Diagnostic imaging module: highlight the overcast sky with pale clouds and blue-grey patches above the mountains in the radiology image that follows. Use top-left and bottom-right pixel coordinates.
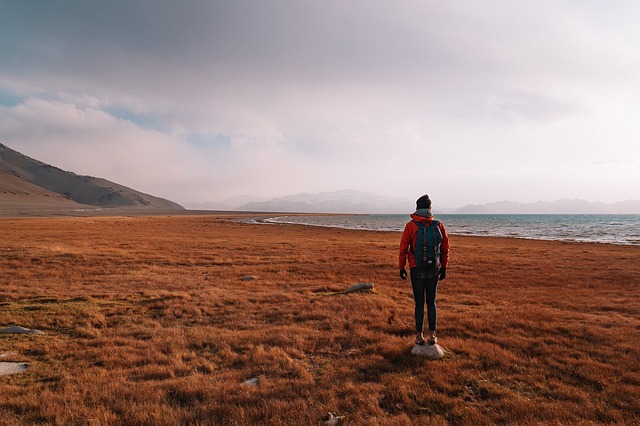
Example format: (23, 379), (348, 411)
(0, 0), (640, 207)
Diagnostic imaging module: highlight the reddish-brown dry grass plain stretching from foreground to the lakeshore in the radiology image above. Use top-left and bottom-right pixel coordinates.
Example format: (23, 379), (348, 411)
(0, 216), (640, 425)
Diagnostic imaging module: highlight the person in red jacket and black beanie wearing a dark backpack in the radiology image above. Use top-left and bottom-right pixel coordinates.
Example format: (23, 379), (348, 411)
(398, 194), (449, 345)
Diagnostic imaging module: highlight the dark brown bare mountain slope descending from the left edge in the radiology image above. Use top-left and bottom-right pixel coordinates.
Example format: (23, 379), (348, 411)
(0, 144), (183, 211)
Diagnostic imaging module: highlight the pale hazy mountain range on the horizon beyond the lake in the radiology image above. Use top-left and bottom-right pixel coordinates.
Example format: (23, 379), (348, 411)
(227, 190), (640, 214)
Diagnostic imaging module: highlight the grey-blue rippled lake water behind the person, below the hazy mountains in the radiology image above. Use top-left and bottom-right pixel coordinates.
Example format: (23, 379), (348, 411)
(254, 214), (640, 245)
